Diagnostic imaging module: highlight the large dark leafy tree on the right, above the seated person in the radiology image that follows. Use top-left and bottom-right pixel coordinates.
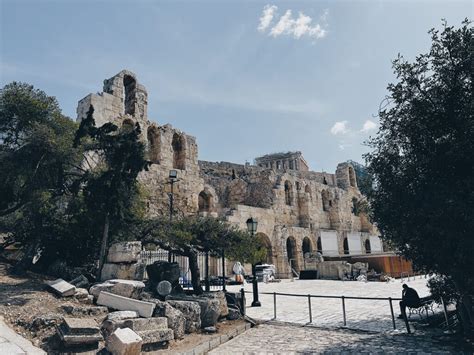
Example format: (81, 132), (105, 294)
(366, 19), (474, 336)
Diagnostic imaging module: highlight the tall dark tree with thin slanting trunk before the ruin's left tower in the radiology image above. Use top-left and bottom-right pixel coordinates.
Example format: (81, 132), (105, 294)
(74, 106), (149, 275)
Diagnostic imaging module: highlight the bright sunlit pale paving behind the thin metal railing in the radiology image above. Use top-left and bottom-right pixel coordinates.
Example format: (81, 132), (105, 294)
(228, 276), (436, 332)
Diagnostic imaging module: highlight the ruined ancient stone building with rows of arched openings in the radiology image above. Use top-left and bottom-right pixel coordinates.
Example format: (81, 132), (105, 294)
(77, 70), (382, 277)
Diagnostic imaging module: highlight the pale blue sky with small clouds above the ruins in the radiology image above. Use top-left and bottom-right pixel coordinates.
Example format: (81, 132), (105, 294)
(0, 0), (473, 172)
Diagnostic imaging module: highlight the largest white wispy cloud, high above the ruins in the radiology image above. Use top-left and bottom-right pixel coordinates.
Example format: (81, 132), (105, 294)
(257, 5), (329, 39)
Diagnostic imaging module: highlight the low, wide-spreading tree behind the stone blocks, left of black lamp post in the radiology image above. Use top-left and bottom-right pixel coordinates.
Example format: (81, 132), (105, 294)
(141, 216), (266, 294)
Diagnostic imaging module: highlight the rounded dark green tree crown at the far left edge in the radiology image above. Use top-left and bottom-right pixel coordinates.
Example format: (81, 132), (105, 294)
(0, 82), (79, 216)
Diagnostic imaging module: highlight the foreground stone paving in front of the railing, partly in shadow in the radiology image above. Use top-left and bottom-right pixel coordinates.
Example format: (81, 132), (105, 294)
(209, 322), (467, 355)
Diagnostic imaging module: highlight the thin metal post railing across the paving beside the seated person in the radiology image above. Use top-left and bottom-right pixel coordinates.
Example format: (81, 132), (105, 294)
(245, 291), (410, 333)
